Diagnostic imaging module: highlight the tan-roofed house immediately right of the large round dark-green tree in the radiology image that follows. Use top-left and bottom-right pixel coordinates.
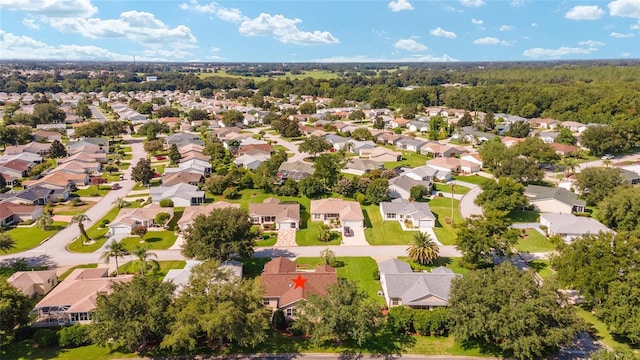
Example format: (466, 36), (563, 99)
(249, 197), (300, 230)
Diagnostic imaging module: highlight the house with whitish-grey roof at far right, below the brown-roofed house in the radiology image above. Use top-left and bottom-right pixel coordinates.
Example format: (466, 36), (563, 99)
(540, 213), (613, 243)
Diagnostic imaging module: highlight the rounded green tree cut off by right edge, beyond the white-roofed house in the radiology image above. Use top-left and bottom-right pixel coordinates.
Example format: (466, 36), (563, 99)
(597, 186), (640, 231)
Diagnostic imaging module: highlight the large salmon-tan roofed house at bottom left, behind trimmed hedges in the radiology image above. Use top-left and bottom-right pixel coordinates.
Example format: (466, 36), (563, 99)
(32, 268), (133, 326)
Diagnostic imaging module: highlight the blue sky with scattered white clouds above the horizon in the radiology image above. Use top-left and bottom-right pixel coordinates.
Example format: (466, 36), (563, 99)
(0, 0), (640, 62)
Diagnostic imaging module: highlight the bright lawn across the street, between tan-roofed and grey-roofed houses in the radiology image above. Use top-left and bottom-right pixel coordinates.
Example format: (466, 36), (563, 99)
(362, 205), (415, 245)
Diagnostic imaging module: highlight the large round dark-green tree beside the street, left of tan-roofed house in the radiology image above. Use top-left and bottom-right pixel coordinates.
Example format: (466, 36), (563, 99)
(182, 208), (255, 261)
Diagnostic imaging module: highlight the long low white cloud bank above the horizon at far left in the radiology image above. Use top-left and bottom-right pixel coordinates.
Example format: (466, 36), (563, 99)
(0, 30), (139, 61)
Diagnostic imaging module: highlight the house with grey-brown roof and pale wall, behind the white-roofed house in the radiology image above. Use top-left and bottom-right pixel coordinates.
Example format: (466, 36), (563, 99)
(524, 185), (587, 214)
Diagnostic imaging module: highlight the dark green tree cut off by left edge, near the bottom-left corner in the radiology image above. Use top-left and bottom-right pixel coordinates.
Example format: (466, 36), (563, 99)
(0, 282), (33, 338)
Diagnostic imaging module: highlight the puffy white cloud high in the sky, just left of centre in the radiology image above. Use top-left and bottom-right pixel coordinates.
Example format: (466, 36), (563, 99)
(238, 13), (340, 45)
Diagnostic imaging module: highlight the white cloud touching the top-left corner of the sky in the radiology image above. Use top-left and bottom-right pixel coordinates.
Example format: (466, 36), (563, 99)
(0, 0), (98, 17)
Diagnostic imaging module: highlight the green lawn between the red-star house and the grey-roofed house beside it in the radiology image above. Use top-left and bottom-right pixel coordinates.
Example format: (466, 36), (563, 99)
(296, 256), (385, 306)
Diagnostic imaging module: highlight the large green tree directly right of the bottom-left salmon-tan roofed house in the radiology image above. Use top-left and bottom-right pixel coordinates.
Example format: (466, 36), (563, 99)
(90, 276), (176, 352)
